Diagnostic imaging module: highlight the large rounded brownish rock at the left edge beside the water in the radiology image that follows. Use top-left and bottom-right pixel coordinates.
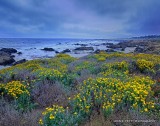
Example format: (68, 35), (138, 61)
(0, 51), (15, 65)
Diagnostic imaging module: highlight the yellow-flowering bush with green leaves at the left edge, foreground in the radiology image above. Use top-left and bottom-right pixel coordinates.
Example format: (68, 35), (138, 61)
(0, 81), (35, 111)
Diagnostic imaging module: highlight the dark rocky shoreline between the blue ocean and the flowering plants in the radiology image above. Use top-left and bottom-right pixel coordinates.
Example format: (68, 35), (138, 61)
(0, 39), (160, 69)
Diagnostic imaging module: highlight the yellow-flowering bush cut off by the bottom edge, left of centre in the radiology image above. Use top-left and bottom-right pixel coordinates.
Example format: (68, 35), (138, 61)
(39, 105), (85, 126)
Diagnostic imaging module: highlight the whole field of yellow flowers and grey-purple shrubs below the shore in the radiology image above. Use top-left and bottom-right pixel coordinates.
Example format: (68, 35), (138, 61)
(0, 52), (160, 126)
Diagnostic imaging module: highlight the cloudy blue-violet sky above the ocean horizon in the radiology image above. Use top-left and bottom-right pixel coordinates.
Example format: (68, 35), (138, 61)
(0, 0), (160, 39)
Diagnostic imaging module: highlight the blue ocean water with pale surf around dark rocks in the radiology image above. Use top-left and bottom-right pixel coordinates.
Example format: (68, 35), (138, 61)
(0, 38), (118, 68)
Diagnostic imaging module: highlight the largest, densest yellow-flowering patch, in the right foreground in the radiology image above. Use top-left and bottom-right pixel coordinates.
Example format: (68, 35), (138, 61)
(71, 76), (154, 116)
